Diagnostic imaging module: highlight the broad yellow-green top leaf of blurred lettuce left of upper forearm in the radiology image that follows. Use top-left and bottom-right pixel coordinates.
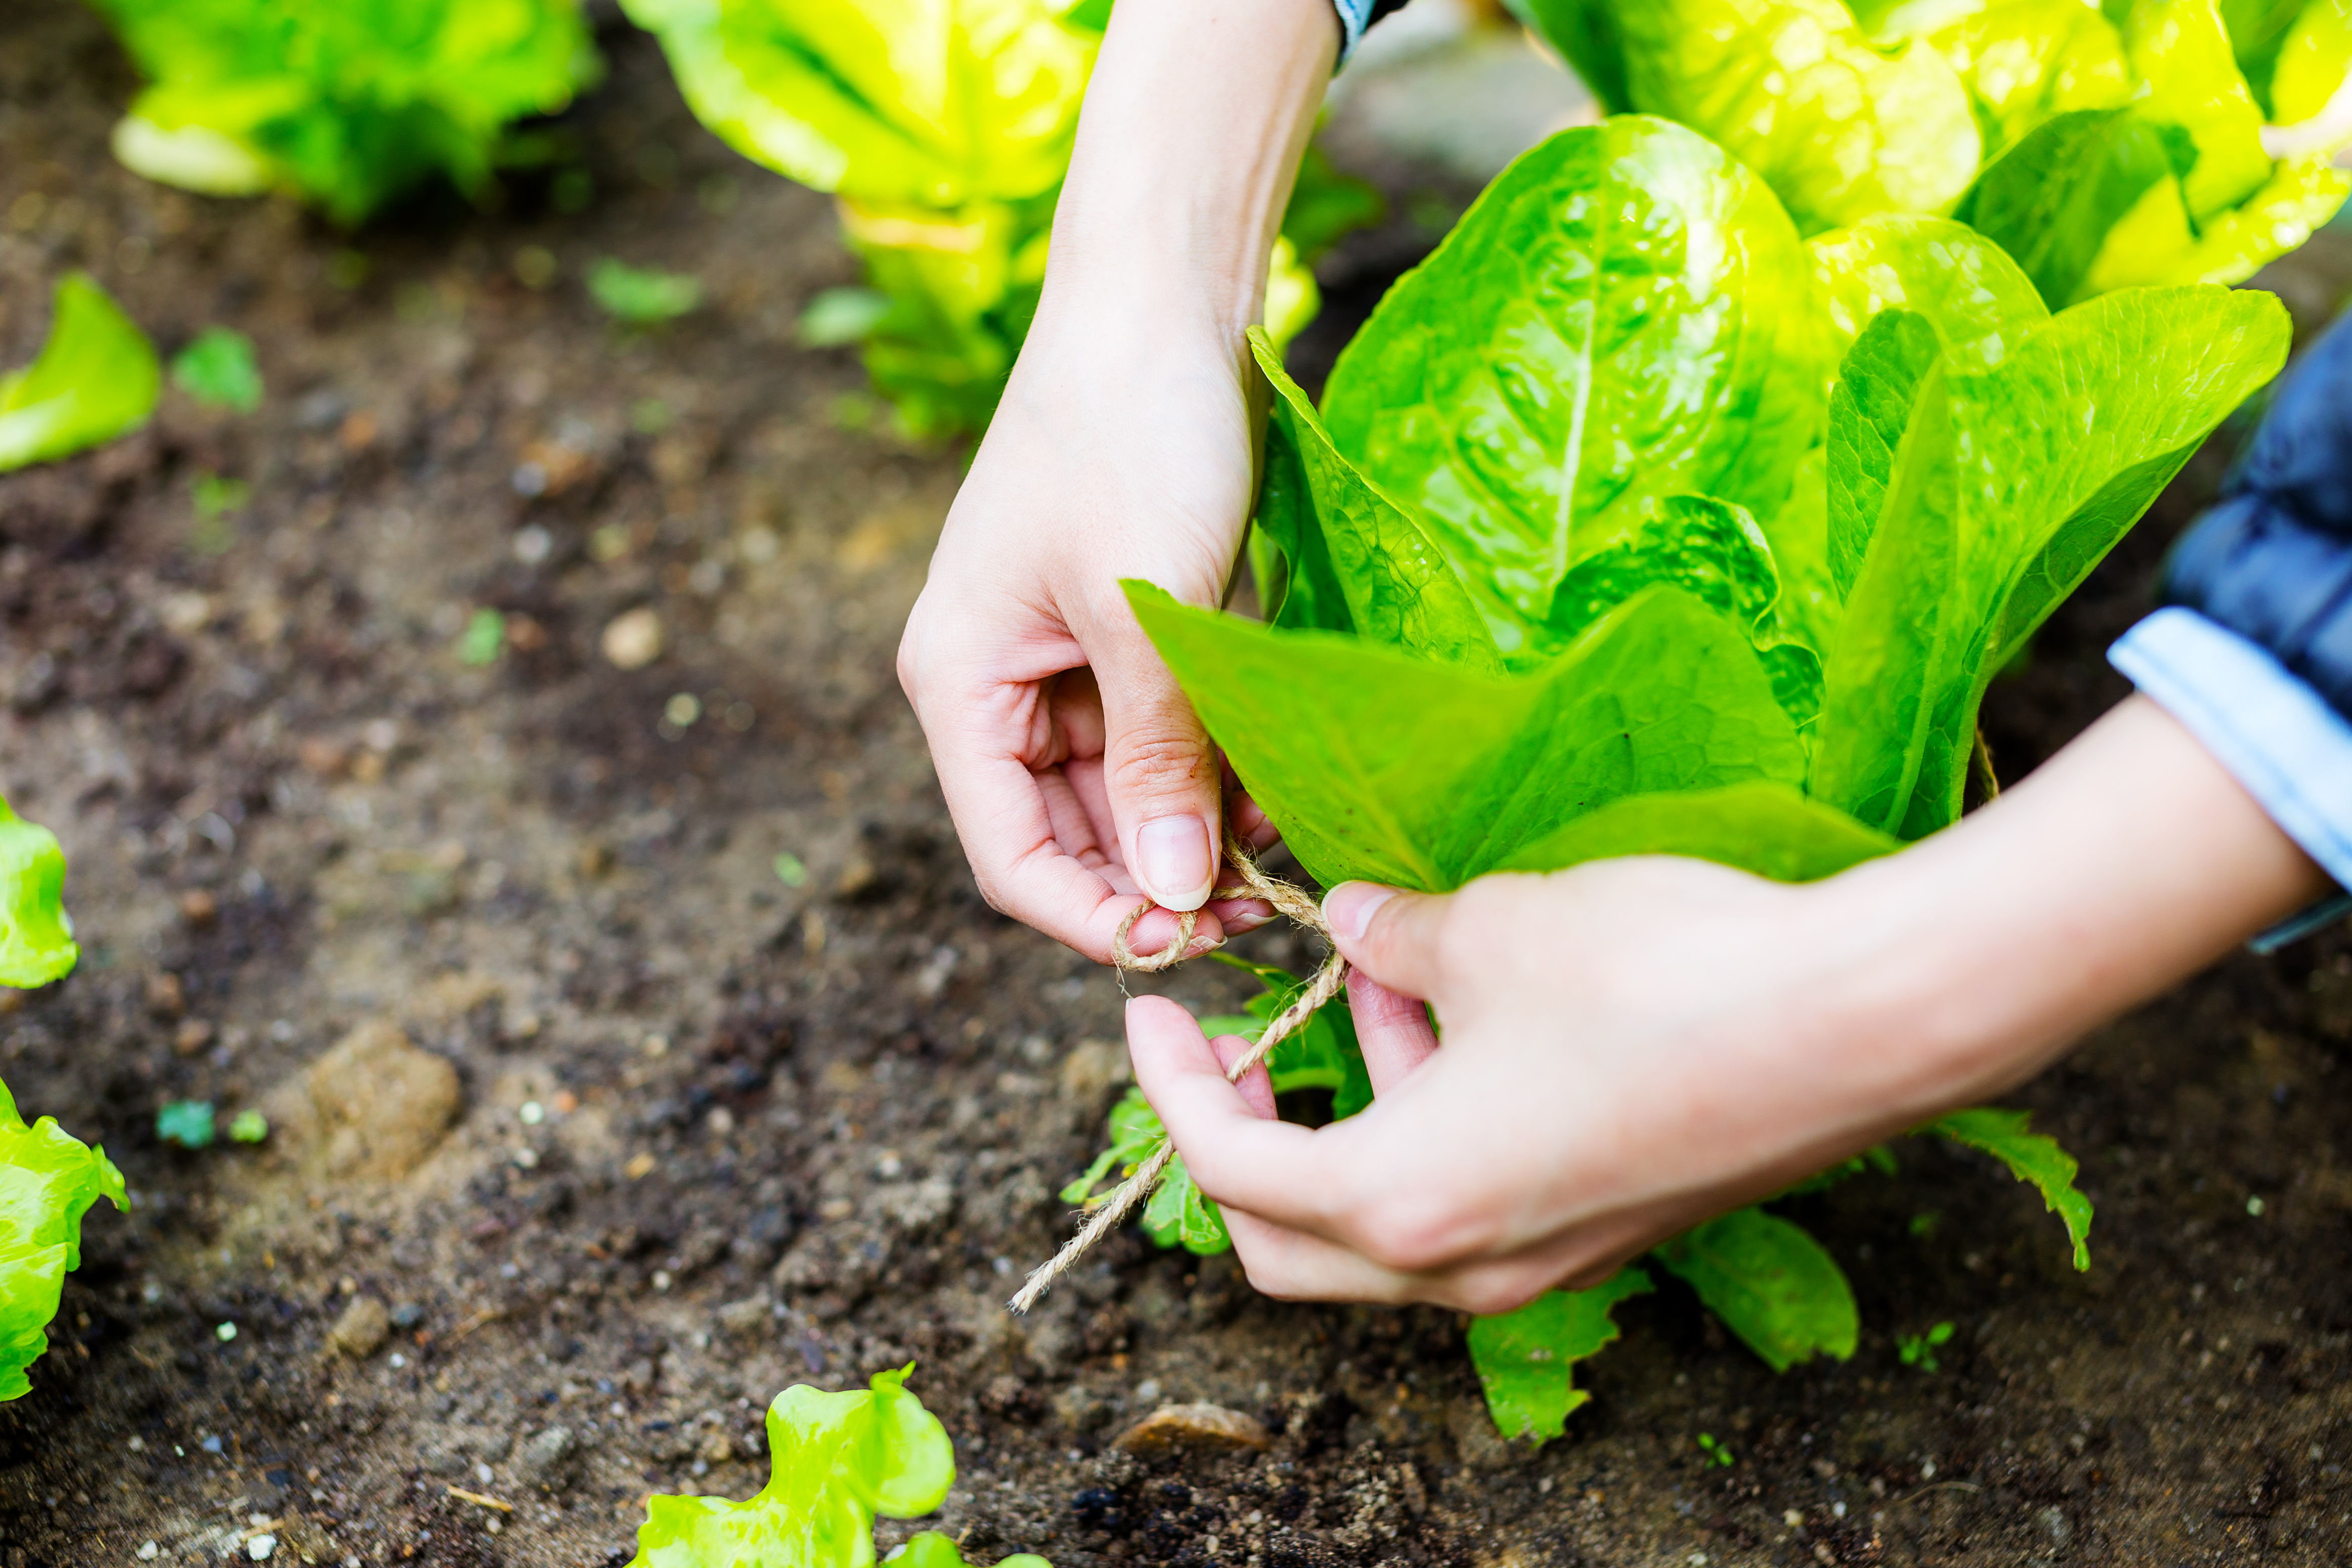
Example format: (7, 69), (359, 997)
(621, 0), (1101, 209)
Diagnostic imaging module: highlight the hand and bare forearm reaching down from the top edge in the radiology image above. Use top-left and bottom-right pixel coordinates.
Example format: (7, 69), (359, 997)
(898, 0), (1338, 962)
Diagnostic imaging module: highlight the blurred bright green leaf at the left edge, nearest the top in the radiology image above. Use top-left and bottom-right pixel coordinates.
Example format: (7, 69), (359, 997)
(0, 273), (162, 472)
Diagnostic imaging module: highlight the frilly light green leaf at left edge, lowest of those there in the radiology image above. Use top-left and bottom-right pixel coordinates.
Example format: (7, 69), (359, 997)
(0, 1084), (129, 1401)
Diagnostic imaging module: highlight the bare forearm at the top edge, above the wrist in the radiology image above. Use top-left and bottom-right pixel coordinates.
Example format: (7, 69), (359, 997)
(1039, 0), (1338, 351)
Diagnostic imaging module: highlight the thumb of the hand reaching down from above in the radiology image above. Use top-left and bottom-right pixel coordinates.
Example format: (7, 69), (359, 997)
(1086, 602), (1226, 910)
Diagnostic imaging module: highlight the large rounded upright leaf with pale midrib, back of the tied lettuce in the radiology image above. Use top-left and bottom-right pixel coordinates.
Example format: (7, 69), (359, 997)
(1326, 117), (1825, 668)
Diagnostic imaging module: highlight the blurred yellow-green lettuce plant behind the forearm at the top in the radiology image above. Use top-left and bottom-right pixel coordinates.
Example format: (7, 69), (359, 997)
(623, 0), (1378, 437)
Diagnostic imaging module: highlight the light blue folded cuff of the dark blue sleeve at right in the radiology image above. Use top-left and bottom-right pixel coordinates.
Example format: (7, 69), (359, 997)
(2107, 606), (2352, 952)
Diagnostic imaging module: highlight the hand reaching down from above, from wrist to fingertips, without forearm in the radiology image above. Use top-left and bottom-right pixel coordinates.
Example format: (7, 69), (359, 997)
(898, 301), (1273, 962)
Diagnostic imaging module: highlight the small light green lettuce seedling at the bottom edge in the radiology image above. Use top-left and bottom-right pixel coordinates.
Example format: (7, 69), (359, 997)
(630, 1364), (1047, 1568)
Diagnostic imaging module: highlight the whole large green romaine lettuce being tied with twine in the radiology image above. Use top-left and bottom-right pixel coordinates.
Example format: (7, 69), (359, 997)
(1070, 117), (2288, 1439)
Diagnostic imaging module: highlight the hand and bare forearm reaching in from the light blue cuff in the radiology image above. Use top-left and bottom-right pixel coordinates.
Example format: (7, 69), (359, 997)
(1129, 698), (2326, 1314)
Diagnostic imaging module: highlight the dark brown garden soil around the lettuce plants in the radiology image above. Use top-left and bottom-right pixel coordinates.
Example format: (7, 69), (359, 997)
(0, 0), (2352, 1568)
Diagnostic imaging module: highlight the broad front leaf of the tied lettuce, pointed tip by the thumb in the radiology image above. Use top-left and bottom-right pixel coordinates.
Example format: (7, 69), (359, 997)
(1126, 583), (1804, 891)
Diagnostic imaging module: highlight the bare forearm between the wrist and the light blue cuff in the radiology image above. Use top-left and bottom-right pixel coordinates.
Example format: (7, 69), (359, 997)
(1820, 698), (2329, 1110)
